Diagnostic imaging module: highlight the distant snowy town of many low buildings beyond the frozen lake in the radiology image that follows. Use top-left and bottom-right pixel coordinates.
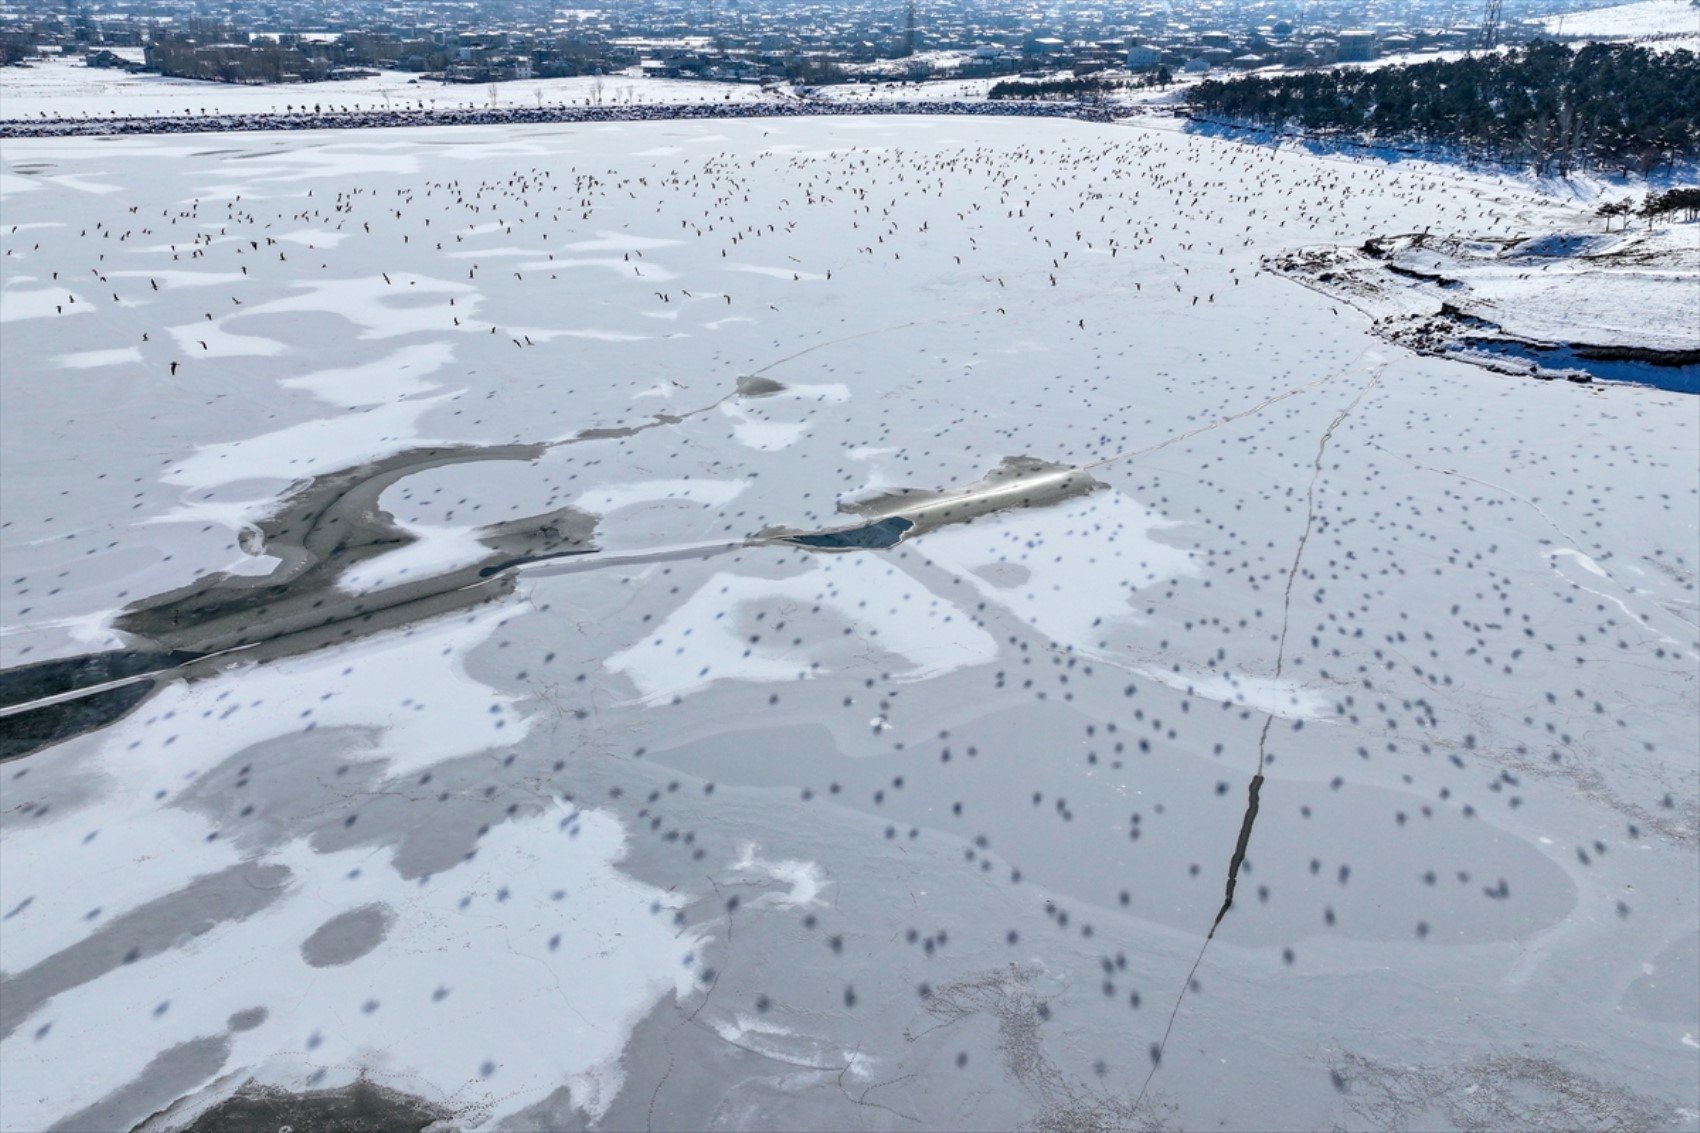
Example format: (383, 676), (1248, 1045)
(0, 0), (1652, 85)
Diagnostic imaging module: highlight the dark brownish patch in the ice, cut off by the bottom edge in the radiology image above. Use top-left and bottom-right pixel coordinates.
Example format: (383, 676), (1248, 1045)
(155, 1079), (454, 1133)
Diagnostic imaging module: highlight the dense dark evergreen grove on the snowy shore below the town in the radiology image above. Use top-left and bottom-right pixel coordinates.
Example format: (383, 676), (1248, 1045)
(1190, 41), (1700, 175)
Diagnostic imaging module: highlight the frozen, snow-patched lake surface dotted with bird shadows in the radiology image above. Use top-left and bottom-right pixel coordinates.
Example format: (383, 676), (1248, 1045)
(0, 108), (1700, 1130)
